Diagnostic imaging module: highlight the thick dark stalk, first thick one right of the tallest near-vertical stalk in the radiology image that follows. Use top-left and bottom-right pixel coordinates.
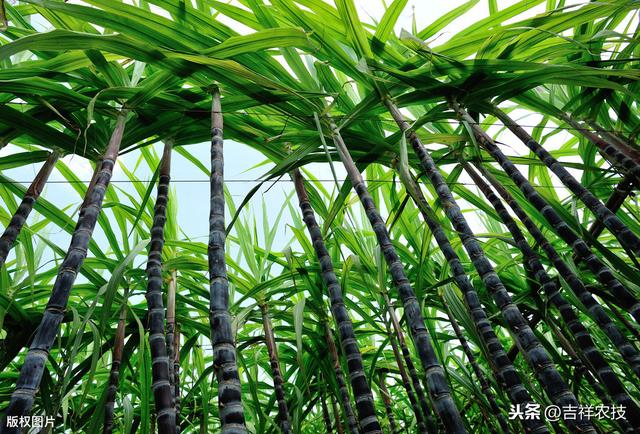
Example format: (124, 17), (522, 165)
(291, 169), (382, 434)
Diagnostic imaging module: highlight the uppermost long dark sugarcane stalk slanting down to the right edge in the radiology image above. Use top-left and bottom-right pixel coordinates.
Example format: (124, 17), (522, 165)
(493, 108), (640, 256)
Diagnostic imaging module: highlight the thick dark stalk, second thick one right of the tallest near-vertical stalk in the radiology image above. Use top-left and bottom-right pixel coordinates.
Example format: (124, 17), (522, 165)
(329, 116), (466, 434)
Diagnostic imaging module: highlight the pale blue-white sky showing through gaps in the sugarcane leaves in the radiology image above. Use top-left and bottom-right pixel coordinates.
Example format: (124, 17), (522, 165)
(0, 0), (604, 264)
